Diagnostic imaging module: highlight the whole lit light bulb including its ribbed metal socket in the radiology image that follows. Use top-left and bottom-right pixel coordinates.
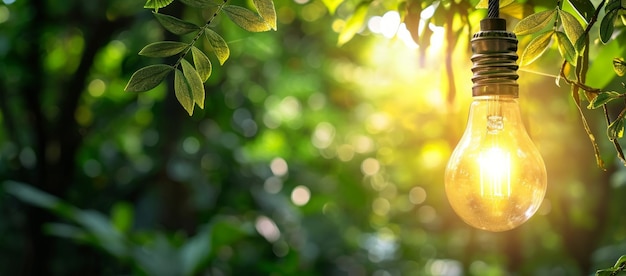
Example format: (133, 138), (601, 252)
(444, 19), (547, 232)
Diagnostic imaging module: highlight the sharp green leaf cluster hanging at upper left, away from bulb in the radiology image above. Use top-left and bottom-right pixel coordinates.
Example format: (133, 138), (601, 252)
(124, 0), (277, 116)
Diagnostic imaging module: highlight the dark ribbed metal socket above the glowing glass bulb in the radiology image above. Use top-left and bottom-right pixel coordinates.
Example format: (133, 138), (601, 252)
(472, 18), (519, 97)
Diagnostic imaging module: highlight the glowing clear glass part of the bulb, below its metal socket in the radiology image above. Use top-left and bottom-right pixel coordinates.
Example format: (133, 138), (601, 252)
(445, 95), (547, 232)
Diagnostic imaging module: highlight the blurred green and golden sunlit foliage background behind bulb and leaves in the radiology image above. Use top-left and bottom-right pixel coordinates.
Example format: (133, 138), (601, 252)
(0, 0), (626, 275)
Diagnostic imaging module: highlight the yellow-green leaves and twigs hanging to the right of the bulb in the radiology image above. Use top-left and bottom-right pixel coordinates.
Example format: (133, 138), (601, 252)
(513, 0), (626, 168)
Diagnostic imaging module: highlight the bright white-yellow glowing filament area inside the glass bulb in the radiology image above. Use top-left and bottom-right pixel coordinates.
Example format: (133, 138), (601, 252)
(478, 147), (512, 198)
